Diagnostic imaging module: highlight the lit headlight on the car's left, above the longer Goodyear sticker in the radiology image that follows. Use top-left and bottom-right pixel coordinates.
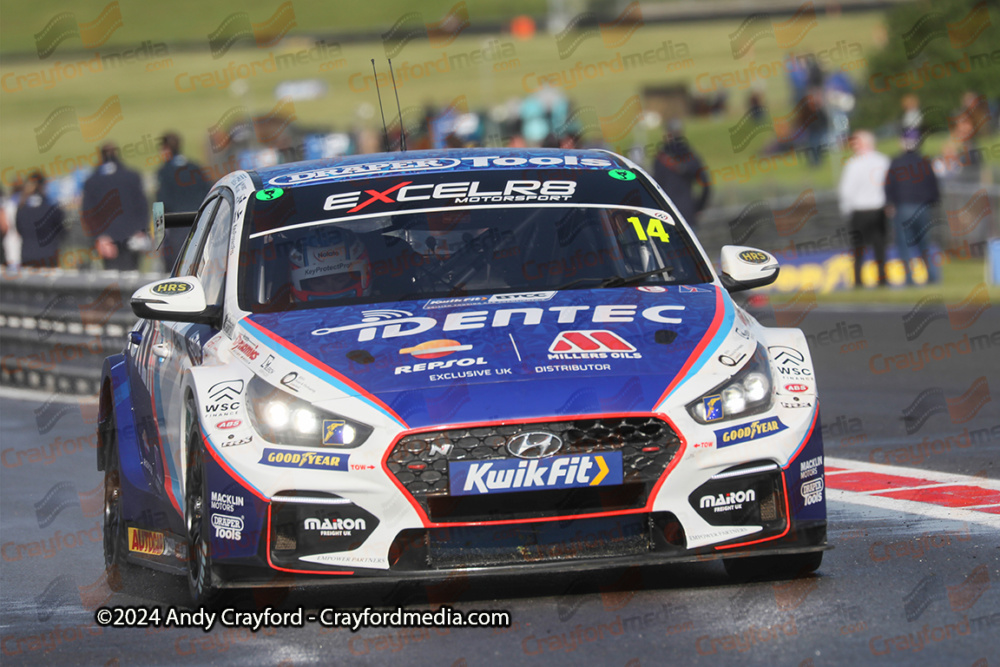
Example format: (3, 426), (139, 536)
(247, 377), (372, 448)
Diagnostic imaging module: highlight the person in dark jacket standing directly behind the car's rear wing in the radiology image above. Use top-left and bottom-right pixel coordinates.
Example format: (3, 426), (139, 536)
(156, 132), (211, 271)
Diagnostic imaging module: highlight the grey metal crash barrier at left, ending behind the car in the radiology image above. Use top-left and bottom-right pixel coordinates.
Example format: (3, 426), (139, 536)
(0, 269), (162, 395)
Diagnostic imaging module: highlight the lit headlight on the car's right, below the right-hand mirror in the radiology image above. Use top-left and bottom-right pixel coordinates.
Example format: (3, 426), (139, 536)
(688, 345), (772, 424)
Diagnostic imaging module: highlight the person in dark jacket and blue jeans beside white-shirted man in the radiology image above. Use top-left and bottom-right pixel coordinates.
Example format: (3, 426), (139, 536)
(885, 128), (941, 285)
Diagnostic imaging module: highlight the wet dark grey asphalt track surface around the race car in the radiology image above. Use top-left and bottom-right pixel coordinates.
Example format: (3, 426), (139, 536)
(0, 308), (1000, 667)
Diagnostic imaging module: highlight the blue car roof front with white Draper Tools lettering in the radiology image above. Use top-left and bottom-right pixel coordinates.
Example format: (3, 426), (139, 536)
(251, 148), (630, 188)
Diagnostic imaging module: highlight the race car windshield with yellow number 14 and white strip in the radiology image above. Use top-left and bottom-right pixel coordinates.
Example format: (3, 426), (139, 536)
(239, 172), (712, 312)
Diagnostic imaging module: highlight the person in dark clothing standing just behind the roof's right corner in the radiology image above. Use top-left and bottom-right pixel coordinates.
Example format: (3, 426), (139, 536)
(653, 121), (712, 227)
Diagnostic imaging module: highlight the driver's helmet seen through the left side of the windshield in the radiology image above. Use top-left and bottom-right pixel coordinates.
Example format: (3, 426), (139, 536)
(289, 229), (372, 302)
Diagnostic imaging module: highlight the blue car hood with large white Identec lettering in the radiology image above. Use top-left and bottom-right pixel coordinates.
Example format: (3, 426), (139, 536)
(236, 285), (733, 428)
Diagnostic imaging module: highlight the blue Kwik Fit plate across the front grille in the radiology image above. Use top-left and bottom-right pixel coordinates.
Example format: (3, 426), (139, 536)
(448, 452), (622, 496)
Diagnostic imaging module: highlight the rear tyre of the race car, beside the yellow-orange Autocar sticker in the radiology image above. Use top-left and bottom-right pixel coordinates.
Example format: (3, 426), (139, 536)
(104, 410), (137, 592)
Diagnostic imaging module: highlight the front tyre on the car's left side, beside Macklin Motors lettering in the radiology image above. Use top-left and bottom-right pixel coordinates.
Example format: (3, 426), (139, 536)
(184, 398), (221, 607)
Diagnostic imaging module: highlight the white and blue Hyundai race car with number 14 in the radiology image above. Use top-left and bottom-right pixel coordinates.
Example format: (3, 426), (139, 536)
(98, 149), (827, 603)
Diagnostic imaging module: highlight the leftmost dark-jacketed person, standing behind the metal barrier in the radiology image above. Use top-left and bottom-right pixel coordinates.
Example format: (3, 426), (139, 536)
(14, 171), (66, 268)
